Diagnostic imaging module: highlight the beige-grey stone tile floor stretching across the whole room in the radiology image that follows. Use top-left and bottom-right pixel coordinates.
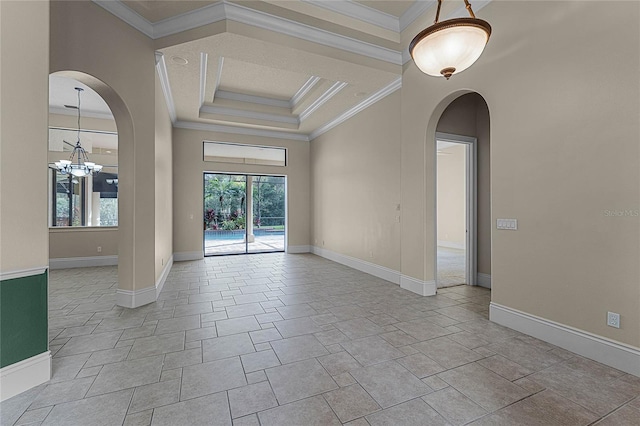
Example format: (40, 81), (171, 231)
(0, 253), (640, 426)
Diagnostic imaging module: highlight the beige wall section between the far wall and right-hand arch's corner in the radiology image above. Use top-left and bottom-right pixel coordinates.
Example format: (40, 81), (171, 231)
(311, 91), (405, 270)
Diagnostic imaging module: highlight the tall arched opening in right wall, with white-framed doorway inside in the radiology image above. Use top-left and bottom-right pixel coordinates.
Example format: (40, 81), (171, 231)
(426, 90), (491, 300)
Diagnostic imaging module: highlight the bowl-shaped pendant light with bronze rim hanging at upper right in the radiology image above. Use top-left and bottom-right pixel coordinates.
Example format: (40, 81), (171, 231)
(409, 0), (491, 80)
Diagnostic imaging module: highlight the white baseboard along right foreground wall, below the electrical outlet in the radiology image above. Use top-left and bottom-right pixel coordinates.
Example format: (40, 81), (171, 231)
(489, 302), (640, 377)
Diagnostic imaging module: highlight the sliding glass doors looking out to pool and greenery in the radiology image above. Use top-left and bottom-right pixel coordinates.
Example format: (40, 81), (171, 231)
(203, 173), (286, 256)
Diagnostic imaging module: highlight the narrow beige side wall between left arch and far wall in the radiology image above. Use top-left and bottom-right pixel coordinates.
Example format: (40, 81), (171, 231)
(155, 73), (173, 282)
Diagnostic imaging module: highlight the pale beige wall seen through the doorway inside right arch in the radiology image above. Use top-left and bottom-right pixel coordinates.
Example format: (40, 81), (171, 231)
(437, 144), (467, 249)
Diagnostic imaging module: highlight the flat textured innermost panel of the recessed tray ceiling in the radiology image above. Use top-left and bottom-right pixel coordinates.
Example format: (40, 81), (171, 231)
(218, 58), (311, 101)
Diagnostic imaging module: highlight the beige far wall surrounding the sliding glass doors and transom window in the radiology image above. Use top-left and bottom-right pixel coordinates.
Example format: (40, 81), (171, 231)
(173, 128), (310, 253)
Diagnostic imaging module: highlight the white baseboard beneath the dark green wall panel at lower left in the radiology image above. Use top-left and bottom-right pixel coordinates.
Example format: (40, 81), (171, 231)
(0, 351), (51, 401)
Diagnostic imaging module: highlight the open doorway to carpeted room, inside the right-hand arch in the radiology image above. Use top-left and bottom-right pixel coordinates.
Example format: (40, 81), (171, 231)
(436, 133), (476, 288)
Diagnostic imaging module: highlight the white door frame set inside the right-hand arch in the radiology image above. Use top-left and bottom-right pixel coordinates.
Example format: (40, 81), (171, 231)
(433, 132), (478, 289)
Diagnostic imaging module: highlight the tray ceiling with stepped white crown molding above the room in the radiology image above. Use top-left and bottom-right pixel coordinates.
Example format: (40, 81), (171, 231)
(94, 0), (488, 140)
